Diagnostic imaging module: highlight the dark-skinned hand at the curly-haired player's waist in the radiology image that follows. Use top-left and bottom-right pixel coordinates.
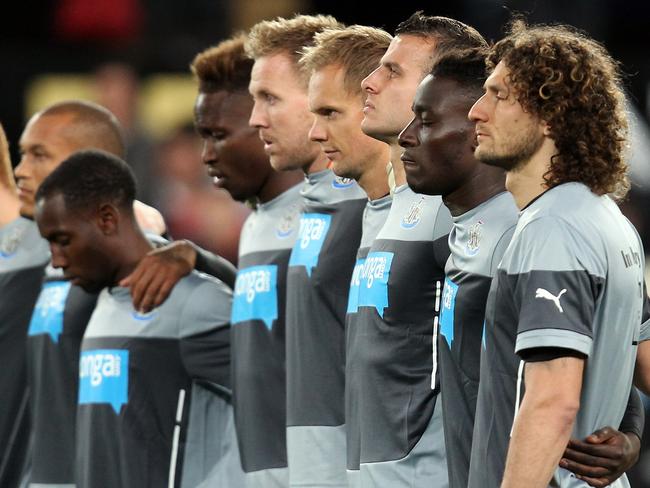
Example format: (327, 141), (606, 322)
(560, 427), (641, 488)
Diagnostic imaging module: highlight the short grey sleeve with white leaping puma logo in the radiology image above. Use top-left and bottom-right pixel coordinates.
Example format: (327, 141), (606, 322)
(508, 217), (604, 356)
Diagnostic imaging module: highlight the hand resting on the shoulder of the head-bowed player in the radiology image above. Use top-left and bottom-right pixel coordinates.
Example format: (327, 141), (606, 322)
(120, 241), (196, 313)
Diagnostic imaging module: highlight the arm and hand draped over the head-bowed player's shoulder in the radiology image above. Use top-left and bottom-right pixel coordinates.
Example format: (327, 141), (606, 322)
(120, 240), (237, 312)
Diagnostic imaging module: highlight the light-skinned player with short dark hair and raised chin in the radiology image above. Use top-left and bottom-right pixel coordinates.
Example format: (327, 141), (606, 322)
(348, 13), (485, 487)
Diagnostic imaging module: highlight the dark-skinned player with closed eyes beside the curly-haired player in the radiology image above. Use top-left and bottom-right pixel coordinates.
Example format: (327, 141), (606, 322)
(400, 45), (643, 488)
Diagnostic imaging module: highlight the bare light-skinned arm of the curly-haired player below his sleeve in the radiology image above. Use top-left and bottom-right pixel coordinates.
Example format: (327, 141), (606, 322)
(502, 351), (584, 488)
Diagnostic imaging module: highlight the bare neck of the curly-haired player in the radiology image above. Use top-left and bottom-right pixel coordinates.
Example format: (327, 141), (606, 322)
(506, 138), (557, 209)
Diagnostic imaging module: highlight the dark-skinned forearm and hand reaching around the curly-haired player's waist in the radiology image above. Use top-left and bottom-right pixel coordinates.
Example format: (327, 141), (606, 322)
(560, 387), (645, 488)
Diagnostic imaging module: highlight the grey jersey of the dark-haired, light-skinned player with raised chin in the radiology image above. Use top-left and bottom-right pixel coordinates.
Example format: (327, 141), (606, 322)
(348, 186), (452, 486)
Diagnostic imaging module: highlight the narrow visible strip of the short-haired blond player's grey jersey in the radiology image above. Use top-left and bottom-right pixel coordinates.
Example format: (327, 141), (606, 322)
(345, 195), (393, 480)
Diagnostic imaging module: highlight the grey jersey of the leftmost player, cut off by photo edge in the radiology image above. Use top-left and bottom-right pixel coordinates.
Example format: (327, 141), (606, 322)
(0, 217), (50, 487)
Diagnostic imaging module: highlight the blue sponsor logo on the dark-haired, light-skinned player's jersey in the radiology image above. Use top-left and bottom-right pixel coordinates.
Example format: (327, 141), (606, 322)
(358, 252), (393, 318)
